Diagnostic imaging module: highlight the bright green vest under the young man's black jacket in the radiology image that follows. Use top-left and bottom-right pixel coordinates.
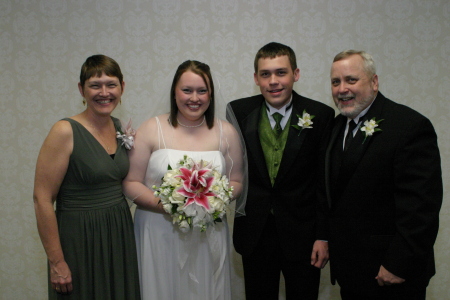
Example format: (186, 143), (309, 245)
(259, 104), (292, 186)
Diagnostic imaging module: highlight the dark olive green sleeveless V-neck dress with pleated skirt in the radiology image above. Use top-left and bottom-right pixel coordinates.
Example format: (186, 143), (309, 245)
(49, 118), (140, 300)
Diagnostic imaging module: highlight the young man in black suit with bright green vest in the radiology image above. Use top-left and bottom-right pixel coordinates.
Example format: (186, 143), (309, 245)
(230, 43), (334, 300)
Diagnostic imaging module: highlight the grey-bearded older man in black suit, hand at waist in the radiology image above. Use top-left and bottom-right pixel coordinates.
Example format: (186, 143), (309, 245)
(323, 50), (442, 300)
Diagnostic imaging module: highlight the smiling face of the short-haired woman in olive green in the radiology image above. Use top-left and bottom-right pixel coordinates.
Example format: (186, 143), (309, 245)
(78, 73), (125, 115)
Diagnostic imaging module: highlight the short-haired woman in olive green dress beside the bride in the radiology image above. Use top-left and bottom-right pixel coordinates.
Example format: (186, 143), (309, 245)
(33, 55), (140, 299)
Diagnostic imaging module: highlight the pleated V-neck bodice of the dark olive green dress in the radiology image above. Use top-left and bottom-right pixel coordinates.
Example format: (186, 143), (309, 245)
(57, 118), (129, 210)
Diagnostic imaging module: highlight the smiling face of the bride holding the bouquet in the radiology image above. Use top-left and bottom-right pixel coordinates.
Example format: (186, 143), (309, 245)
(175, 71), (210, 122)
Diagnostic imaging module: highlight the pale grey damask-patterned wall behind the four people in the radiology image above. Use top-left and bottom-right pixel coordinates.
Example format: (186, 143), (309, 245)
(0, 0), (450, 299)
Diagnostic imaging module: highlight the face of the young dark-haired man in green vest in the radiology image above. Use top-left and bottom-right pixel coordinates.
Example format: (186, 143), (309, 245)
(254, 55), (300, 109)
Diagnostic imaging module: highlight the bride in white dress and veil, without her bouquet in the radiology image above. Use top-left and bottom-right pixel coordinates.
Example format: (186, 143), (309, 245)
(124, 61), (245, 300)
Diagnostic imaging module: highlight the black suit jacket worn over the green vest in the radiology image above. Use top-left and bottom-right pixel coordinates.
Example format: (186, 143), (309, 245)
(230, 92), (334, 261)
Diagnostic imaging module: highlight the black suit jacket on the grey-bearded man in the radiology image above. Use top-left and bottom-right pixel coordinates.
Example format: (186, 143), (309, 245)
(322, 93), (442, 291)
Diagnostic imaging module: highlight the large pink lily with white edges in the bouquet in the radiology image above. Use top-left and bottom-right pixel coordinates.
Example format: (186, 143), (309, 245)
(176, 162), (216, 210)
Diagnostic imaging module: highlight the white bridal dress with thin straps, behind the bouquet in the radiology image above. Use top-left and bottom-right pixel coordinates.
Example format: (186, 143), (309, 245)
(134, 119), (231, 300)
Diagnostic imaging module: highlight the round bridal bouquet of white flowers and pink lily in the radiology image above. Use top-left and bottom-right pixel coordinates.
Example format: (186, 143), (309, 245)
(152, 155), (233, 232)
